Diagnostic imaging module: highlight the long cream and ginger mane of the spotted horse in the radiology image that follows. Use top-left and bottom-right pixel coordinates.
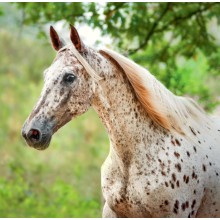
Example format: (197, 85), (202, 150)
(101, 49), (211, 135)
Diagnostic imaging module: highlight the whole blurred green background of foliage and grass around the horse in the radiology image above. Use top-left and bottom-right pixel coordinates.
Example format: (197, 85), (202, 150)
(0, 3), (220, 217)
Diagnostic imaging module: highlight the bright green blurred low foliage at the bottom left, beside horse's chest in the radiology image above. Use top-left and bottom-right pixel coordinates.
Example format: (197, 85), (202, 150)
(0, 166), (101, 218)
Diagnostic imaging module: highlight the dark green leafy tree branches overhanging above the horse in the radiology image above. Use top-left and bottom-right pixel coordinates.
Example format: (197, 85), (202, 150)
(12, 2), (220, 69)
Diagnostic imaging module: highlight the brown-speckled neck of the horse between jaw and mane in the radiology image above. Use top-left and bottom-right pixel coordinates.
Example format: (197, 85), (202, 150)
(84, 48), (162, 162)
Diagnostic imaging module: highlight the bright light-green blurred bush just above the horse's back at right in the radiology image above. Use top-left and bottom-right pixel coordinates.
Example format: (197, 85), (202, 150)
(169, 53), (218, 110)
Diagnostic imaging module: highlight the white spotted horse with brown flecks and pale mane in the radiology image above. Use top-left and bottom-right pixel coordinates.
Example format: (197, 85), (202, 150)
(22, 26), (220, 217)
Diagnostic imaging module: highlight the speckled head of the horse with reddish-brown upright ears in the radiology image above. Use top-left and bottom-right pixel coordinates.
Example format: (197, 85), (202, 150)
(22, 26), (95, 150)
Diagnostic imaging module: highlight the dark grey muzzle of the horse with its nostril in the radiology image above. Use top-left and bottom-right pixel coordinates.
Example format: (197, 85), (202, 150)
(21, 121), (52, 150)
